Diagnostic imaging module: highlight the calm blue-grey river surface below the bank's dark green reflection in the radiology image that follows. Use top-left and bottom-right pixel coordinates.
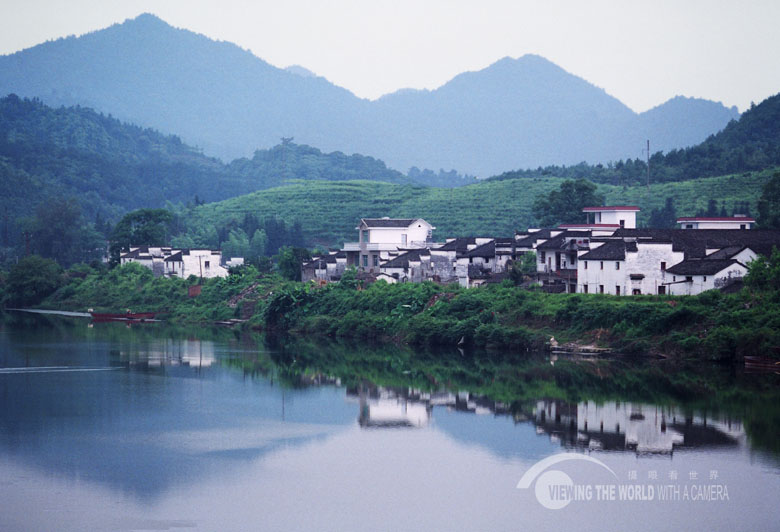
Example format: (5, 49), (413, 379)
(0, 317), (780, 531)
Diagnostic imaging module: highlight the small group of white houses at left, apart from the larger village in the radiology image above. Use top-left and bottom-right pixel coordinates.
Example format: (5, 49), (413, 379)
(119, 246), (244, 278)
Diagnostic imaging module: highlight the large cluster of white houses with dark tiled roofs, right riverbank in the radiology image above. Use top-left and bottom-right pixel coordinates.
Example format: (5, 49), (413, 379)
(302, 206), (780, 295)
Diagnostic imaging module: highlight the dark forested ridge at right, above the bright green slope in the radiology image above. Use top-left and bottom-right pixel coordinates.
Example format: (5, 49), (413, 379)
(490, 94), (780, 185)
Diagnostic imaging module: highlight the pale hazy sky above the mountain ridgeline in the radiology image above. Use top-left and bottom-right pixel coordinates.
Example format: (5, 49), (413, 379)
(0, 0), (780, 111)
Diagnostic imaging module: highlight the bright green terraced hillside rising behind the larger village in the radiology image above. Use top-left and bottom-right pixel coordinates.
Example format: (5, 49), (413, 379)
(183, 170), (775, 246)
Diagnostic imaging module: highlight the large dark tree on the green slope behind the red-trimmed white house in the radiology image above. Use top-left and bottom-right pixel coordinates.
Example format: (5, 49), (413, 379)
(533, 179), (604, 227)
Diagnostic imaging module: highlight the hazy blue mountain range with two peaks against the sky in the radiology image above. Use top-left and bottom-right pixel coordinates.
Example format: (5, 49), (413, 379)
(0, 14), (738, 176)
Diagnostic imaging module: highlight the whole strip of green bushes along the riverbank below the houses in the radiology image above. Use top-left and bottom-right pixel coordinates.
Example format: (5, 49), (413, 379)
(0, 250), (780, 361)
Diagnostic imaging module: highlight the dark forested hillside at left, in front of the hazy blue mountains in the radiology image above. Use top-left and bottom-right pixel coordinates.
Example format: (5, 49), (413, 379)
(0, 95), (426, 247)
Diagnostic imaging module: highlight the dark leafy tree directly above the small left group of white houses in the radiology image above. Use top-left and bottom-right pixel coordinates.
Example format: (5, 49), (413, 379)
(109, 209), (173, 265)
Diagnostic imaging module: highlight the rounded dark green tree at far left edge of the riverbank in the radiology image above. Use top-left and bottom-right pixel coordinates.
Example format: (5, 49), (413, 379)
(6, 255), (62, 306)
